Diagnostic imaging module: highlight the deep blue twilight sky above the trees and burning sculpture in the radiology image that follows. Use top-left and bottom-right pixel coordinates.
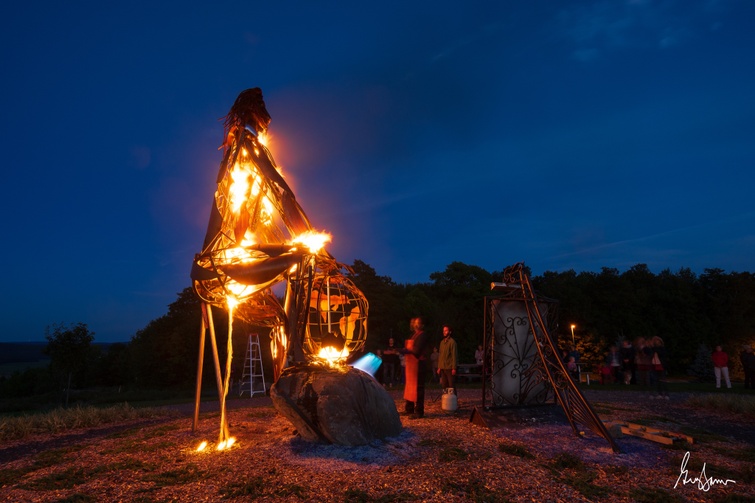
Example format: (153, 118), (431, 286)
(0, 0), (755, 342)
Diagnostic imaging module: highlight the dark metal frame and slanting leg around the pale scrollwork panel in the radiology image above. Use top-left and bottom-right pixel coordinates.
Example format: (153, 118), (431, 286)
(482, 262), (620, 452)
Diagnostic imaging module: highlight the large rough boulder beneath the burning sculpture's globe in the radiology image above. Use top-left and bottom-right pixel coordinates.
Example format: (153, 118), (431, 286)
(270, 364), (401, 445)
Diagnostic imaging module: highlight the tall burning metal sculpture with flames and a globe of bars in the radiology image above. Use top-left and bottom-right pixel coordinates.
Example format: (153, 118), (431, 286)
(191, 88), (400, 448)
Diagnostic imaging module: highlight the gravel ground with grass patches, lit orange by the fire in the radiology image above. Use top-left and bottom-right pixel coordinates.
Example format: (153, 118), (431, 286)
(0, 389), (755, 503)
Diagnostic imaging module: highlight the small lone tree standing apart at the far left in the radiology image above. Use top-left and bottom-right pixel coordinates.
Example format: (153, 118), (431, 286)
(45, 323), (94, 407)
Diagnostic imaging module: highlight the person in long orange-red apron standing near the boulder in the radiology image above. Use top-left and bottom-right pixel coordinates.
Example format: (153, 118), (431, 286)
(399, 317), (430, 419)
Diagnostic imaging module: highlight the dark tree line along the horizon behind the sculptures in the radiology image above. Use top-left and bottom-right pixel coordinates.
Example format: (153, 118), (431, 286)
(0, 260), (755, 406)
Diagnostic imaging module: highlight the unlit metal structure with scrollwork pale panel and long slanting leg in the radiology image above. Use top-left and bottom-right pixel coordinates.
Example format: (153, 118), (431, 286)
(482, 262), (619, 452)
